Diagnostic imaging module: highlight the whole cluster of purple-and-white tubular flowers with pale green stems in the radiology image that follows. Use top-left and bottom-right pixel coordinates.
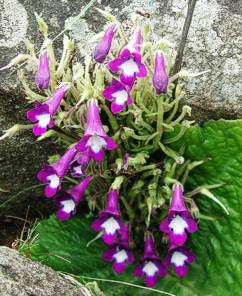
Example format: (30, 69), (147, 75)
(2, 9), (223, 287)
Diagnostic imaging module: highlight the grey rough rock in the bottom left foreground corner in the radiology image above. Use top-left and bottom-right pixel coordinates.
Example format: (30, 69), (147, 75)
(0, 247), (91, 296)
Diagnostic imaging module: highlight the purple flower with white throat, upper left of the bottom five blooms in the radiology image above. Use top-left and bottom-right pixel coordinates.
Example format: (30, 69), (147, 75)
(92, 190), (124, 245)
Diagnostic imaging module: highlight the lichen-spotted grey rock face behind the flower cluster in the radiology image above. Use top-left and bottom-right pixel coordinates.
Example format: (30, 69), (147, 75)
(0, 0), (242, 206)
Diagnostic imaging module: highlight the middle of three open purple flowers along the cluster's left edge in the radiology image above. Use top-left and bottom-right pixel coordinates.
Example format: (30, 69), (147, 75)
(37, 147), (77, 197)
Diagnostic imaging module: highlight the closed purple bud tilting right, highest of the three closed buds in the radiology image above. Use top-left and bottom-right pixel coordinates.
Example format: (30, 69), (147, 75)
(93, 24), (117, 63)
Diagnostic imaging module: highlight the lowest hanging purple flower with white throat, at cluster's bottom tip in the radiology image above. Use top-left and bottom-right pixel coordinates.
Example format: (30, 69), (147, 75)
(133, 235), (167, 287)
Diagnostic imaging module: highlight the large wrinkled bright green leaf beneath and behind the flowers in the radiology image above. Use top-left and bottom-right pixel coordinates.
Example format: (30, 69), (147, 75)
(22, 120), (242, 296)
